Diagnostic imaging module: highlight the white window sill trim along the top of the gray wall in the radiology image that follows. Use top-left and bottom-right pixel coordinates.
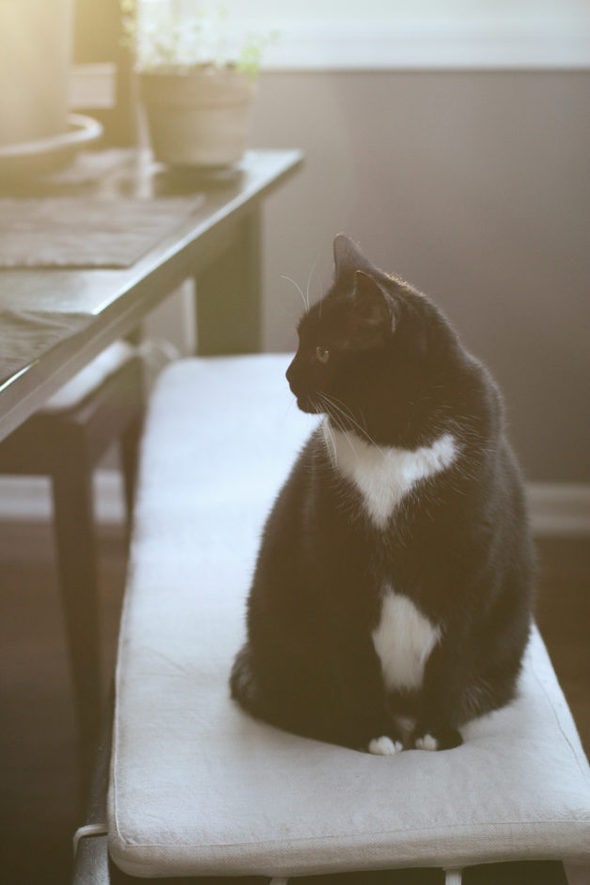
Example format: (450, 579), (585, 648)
(263, 16), (590, 71)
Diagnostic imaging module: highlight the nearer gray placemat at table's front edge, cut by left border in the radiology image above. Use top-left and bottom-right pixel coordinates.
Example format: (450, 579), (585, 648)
(0, 309), (94, 384)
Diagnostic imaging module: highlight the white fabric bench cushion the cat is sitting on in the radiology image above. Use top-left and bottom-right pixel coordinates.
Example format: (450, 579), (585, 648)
(109, 355), (590, 876)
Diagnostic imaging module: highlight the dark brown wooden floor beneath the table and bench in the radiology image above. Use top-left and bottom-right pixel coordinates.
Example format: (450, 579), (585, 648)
(0, 523), (590, 885)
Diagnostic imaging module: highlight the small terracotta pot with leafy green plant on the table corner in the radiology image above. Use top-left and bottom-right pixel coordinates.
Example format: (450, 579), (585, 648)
(122, 0), (272, 168)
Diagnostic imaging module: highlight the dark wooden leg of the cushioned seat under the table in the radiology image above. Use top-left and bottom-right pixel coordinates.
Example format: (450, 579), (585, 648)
(53, 452), (101, 773)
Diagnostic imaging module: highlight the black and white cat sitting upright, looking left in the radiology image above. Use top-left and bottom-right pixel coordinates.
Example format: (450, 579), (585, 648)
(231, 235), (534, 754)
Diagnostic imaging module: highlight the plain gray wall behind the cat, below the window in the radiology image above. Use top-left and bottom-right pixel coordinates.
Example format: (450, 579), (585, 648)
(253, 72), (590, 482)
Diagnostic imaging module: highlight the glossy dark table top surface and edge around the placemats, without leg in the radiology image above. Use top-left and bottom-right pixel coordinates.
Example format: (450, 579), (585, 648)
(0, 150), (302, 439)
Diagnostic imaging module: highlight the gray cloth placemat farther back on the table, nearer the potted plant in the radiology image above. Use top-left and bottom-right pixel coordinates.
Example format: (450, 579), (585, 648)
(0, 196), (204, 268)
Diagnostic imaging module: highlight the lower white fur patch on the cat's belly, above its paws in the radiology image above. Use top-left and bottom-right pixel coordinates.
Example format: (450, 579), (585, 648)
(372, 587), (441, 691)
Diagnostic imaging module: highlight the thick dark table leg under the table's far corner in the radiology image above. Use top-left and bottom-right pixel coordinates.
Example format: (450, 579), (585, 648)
(196, 209), (262, 355)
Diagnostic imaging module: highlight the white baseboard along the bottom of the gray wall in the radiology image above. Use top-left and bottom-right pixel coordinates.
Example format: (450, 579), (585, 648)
(0, 470), (590, 537)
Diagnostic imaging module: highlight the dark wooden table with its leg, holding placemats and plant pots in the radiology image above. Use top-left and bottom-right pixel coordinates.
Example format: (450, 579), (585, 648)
(0, 150), (302, 448)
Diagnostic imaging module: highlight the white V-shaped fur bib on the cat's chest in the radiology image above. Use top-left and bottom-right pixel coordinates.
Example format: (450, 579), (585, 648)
(323, 419), (457, 529)
